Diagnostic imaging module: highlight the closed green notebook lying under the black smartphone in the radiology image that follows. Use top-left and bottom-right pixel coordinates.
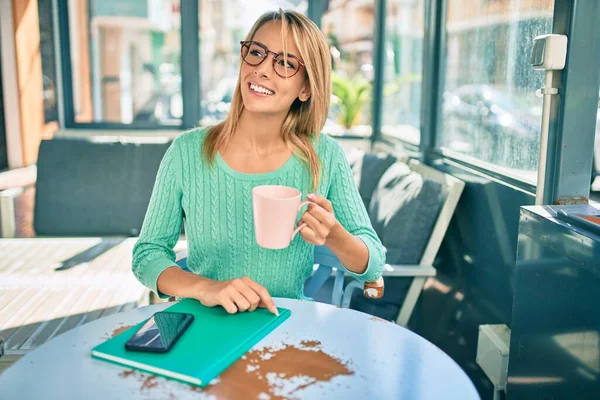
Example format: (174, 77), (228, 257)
(92, 299), (290, 386)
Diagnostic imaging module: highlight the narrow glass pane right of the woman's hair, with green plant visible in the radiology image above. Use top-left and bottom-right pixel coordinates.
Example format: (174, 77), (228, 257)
(321, 0), (375, 136)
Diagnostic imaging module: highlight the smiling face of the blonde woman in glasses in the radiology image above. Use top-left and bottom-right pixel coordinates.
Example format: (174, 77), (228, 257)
(240, 21), (310, 116)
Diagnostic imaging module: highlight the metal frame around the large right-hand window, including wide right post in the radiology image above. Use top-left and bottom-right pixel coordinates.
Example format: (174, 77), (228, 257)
(420, 0), (600, 204)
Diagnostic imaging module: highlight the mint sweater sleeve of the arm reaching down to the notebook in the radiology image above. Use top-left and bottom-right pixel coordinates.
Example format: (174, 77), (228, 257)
(132, 139), (183, 298)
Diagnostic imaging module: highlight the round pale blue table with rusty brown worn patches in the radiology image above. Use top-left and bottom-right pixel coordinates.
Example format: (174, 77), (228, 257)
(0, 299), (479, 400)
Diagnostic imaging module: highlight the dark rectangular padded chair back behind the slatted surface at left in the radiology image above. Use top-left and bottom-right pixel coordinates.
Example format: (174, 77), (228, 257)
(34, 138), (170, 236)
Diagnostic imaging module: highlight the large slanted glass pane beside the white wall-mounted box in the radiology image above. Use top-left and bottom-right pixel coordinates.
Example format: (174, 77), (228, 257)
(441, 0), (554, 183)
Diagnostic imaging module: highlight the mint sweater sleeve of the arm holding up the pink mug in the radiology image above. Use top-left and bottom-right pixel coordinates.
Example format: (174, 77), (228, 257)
(327, 140), (385, 282)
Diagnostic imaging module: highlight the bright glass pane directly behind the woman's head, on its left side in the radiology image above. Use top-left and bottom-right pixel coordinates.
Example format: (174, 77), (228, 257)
(199, 0), (308, 126)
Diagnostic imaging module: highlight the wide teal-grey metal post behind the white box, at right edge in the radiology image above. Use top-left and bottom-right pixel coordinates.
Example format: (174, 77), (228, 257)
(543, 0), (600, 204)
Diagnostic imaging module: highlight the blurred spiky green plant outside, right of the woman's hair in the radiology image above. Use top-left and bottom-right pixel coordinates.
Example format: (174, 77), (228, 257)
(332, 74), (371, 129)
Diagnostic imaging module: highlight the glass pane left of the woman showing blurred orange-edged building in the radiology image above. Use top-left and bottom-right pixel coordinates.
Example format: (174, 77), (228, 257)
(69, 0), (183, 125)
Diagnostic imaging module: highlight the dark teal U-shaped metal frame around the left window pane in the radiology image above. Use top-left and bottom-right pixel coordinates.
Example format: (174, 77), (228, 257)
(55, 0), (200, 131)
